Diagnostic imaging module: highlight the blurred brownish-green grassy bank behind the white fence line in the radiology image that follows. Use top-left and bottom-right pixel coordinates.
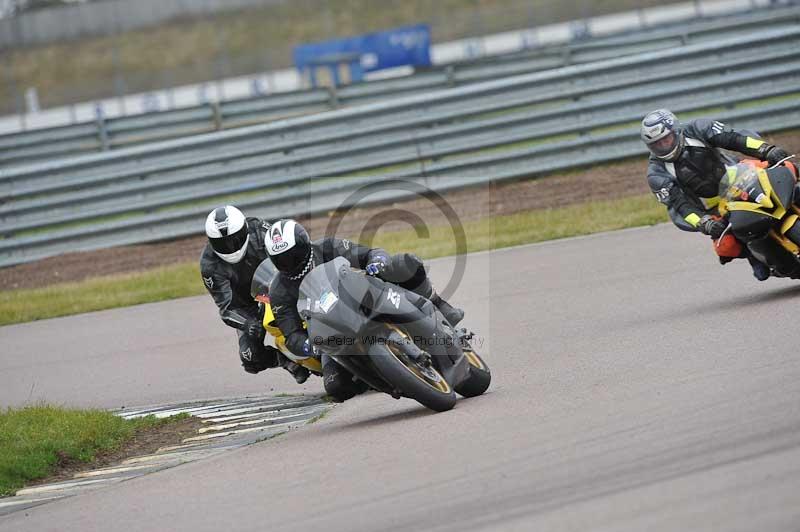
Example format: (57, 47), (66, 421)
(0, 0), (677, 111)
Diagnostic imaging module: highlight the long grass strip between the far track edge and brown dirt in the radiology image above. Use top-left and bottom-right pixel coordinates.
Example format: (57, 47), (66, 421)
(0, 194), (667, 325)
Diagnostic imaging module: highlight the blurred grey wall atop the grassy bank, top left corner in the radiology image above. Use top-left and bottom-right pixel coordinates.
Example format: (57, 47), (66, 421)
(0, 0), (290, 49)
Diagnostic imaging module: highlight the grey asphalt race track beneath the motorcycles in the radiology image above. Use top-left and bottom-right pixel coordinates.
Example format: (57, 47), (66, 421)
(0, 222), (800, 532)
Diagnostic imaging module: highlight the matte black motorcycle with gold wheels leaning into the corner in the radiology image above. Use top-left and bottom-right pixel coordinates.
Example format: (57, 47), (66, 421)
(297, 257), (491, 412)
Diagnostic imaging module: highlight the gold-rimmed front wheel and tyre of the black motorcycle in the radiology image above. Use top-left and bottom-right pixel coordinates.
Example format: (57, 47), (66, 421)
(369, 343), (456, 412)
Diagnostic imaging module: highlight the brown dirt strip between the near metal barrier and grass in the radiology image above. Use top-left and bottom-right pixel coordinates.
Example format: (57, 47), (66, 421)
(6, 132), (800, 290)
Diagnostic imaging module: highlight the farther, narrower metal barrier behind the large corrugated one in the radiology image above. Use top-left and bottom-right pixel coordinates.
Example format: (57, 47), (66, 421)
(0, 7), (800, 167)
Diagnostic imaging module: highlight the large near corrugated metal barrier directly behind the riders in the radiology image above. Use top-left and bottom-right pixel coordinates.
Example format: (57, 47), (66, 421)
(0, 28), (800, 265)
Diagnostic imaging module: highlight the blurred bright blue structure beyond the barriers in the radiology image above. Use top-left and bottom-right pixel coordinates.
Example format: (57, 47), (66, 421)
(293, 24), (431, 87)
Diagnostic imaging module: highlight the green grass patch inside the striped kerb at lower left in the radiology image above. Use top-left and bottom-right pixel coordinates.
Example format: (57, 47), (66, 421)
(0, 405), (184, 496)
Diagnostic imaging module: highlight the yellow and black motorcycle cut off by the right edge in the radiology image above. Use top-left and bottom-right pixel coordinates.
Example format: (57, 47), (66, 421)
(716, 156), (800, 279)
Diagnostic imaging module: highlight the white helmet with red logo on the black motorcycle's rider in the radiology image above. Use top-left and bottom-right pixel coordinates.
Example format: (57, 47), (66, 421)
(265, 220), (314, 281)
